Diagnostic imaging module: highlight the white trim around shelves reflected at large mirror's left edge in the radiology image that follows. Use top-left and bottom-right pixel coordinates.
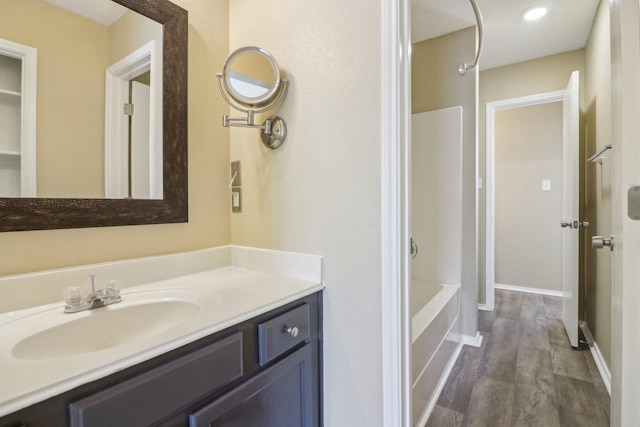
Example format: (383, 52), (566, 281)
(0, 39), (38, 197)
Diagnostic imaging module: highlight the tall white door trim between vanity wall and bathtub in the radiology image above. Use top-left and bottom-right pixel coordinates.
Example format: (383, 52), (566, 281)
(381, 0), (411, 427)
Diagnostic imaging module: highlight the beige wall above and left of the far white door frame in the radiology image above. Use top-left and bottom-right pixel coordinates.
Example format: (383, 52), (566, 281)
(478, 49), (584, 304)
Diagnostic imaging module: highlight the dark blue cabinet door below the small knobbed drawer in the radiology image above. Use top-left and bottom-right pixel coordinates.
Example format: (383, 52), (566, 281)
(189, 344), (319, 427)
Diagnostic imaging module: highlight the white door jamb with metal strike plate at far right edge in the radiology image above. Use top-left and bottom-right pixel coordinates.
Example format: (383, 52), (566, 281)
(610, 0), (640, 427)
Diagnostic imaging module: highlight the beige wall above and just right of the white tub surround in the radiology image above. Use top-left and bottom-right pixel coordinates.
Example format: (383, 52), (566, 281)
(411, 28), (478, 336)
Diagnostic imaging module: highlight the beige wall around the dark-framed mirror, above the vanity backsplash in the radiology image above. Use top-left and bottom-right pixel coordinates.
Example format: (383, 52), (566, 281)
(0, 0), (231, 275)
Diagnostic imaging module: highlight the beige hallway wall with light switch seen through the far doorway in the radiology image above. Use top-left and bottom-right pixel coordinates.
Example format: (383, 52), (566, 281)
(494, 102), (562, 291)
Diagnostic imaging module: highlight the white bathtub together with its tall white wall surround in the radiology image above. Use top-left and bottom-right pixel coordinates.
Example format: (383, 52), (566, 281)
(410, 108), (464, 427)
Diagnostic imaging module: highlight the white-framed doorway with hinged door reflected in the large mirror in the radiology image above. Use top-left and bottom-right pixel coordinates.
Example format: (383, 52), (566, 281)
(105, 41), (163, 199)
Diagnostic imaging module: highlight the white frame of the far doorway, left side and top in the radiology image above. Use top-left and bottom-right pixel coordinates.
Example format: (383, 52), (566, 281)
(479, 90), (566, 311)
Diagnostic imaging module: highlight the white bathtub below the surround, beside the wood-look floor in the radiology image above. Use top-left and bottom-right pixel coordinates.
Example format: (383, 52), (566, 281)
(411, 280), (462, 427)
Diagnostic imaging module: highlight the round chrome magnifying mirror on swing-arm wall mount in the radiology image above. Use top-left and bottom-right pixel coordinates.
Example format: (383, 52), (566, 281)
(216, 46), (289, 149)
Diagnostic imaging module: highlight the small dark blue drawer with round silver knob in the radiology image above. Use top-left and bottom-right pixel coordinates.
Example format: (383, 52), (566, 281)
(258, 303), (310, 366)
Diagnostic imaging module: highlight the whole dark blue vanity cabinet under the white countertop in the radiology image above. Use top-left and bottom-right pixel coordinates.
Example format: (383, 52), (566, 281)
(0, 293), (322, 427)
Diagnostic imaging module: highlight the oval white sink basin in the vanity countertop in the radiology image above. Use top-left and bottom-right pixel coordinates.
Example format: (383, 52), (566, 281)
(12, 300), (200, 360)
